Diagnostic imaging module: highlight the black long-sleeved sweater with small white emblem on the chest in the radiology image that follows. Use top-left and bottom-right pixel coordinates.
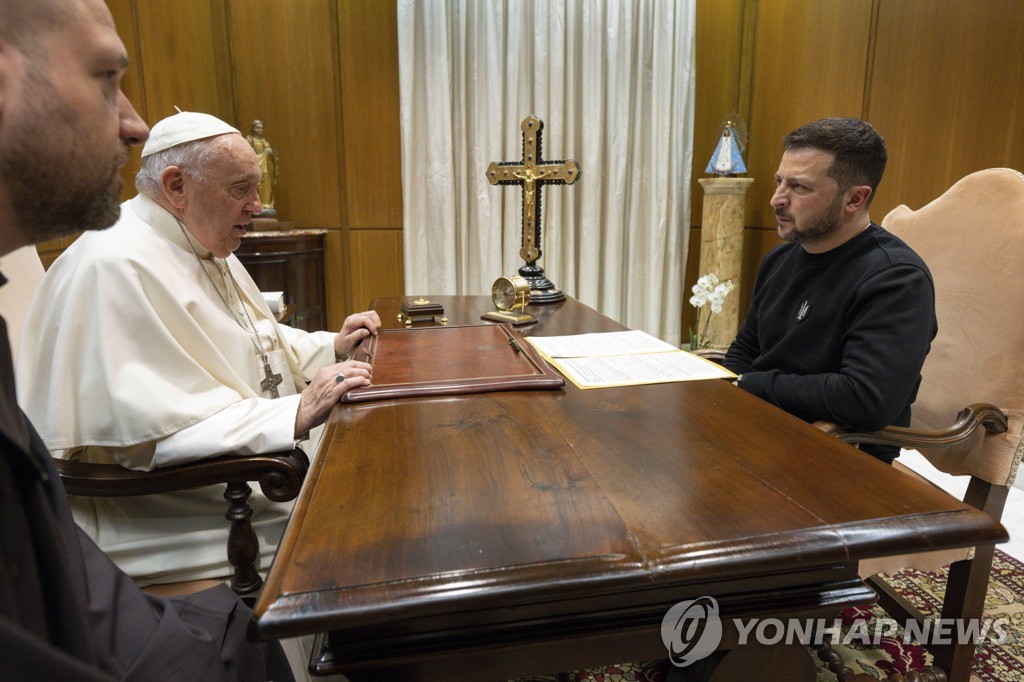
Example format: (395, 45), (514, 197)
(725, 223), (938, 461)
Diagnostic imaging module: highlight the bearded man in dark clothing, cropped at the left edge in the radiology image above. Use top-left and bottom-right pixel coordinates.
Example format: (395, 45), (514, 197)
(0, 0), (292, 682)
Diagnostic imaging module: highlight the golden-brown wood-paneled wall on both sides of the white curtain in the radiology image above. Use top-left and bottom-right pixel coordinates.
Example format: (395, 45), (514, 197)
(39, 0), (1024, 328)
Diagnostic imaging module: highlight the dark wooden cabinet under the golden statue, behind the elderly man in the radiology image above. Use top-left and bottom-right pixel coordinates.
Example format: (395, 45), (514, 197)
(234, 229), (327, 332)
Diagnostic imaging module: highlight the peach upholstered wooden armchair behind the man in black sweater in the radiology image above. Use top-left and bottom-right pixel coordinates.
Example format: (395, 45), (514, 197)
(818, 168), (1024, 681)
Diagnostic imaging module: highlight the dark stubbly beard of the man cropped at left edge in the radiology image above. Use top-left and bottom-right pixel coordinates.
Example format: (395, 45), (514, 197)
(0, 62), (127, 243)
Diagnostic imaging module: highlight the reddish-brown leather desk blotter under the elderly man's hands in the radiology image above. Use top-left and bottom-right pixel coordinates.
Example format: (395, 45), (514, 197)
(341, 325), (565, 402)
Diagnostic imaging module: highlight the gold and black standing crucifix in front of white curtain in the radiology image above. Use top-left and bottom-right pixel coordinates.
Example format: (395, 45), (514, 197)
(487, 116), (581, 303)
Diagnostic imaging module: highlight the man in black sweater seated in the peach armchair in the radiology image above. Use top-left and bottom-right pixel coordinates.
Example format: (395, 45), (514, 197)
(724, 119), (937, 463)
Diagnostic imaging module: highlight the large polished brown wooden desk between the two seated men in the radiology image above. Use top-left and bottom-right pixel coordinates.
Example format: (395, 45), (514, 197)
(252, 296), (1007, 682)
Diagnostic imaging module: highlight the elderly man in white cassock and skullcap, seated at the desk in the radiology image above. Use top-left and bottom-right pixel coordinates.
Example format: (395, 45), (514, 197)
(17, 112), (380, 585)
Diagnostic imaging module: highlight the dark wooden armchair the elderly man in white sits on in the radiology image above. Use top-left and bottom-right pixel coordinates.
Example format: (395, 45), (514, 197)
(0, 247), (309, 600)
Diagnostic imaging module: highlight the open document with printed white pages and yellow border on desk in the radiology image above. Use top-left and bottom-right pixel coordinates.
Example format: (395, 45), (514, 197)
(526, 330), (736, 388)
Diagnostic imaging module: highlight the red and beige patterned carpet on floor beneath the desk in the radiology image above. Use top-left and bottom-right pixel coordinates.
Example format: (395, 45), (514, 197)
(509, 550), (1024, 682)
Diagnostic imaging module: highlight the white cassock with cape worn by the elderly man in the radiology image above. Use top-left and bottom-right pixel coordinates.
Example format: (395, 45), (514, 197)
(17, 196), (335, 585)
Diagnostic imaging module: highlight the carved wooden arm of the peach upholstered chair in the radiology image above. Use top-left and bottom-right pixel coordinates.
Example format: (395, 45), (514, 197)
(814, 402), (1007, 449)
